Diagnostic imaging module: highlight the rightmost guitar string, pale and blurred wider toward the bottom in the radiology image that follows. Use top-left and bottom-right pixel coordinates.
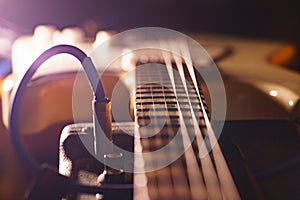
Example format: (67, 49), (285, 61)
(180, 43), (240, 200)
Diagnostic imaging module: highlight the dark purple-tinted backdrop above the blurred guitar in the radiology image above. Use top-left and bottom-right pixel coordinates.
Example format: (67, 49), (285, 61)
(0, 0), (300, 45)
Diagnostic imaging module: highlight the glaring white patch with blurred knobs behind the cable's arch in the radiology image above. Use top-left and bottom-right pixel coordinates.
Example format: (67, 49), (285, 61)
(12, 25), (92, 76)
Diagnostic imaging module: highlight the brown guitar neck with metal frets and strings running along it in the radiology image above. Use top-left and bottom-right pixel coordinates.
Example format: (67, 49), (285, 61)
(134, 61), (240, 199)
